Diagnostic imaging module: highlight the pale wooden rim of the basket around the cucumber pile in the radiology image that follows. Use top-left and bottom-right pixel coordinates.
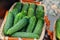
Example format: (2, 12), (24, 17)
(0, 3), (47, 40)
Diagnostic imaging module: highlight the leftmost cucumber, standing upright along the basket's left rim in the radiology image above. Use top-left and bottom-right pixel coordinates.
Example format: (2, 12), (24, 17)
(3, 12), (13, 35)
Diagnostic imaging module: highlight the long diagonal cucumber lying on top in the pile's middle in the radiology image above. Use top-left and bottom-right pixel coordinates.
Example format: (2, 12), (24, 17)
(7, 17), (28, 35)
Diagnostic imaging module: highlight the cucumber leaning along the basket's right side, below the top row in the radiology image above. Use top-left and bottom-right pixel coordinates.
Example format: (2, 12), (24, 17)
(33, 19), (44, 35)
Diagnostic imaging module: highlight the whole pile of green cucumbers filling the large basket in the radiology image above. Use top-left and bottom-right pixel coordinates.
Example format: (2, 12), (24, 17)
(3, 2), (44, 38)
